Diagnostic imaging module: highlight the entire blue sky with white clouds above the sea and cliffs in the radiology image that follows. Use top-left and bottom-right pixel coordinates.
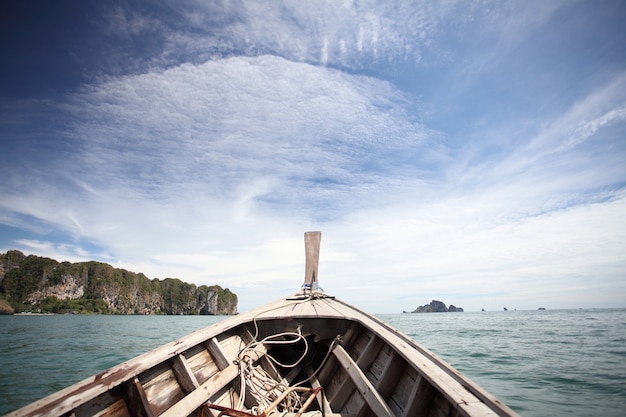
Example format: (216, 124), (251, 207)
(0, 0), (626, 313)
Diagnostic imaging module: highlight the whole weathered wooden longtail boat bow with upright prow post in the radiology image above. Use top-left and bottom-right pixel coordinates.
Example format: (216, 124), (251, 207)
(8, 232), (517, 417)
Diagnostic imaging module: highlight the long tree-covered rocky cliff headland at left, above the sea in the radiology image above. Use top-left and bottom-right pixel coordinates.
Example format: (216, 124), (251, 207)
(0, 250), (237, 315)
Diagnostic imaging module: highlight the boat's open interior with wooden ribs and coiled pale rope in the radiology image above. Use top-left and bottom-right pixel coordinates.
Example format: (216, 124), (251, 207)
(71, 318), (468, 417)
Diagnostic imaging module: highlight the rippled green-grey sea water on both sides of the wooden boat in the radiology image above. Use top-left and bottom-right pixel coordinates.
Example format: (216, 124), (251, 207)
(0, 309), (626, 417)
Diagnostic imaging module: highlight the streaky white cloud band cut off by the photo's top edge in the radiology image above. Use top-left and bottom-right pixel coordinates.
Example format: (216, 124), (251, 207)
(155, 1), (560, 70)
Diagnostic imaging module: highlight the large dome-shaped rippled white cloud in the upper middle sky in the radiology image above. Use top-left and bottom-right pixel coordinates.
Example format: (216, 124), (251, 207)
(61, 56), (433, 210)
